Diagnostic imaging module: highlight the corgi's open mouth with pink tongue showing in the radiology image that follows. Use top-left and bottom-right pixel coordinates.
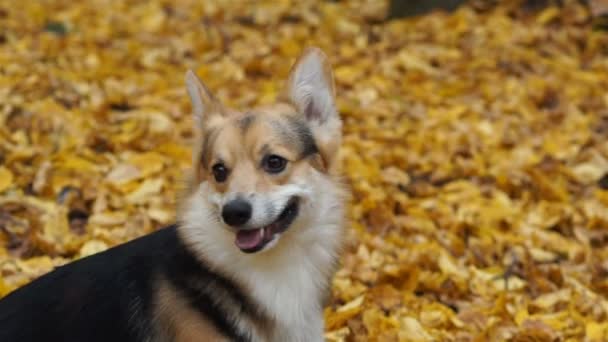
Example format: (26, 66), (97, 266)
(235, 197), (300, 253)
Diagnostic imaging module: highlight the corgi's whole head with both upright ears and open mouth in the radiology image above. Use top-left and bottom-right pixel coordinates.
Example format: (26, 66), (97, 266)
(182, 48), (341, 253)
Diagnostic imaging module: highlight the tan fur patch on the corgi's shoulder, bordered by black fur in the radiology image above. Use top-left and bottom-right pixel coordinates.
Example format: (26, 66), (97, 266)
(156, 281), (228, 342)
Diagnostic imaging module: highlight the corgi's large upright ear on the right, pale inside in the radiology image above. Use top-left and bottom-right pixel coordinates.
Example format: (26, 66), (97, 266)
(283, 48), (342, 170)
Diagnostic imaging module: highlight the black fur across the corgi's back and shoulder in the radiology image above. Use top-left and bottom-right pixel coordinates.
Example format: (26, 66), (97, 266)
(0, 226), (264, 342)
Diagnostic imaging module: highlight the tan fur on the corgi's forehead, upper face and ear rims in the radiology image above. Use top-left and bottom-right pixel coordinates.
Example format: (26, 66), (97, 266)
(188, 48), (341, 196)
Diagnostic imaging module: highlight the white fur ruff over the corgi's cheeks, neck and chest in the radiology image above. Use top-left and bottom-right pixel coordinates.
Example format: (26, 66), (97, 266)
(180, 180), (343, 341)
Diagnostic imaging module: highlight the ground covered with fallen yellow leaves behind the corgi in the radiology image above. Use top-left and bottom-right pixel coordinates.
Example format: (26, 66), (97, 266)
(0, 0), (608, 341)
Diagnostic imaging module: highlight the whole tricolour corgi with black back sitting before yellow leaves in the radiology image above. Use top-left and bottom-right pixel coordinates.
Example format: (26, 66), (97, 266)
(0, 48), (347, 342)
